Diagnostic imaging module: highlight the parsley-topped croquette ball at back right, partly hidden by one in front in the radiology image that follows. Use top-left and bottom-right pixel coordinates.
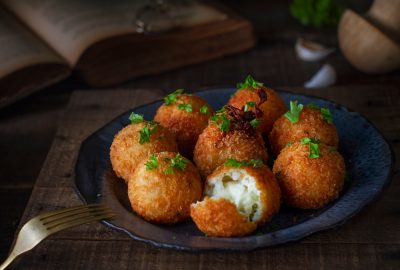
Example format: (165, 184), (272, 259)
(269, 101), (339, 155)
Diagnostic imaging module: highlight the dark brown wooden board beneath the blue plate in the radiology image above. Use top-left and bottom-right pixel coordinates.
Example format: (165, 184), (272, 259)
(6, 85), (400, 269)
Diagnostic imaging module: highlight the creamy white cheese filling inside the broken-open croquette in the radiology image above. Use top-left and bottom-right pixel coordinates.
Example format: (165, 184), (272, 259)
(205, 168), (262, 221)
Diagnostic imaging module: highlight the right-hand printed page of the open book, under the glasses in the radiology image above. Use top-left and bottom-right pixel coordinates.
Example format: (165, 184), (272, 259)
(4, 0), (224, 66)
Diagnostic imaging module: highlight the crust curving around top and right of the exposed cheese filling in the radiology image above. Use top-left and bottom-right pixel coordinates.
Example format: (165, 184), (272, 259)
(206, 165), (281, 225)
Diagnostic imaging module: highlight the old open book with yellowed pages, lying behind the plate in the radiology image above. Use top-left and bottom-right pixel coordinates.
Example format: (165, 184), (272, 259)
(0, 0), (255, 107)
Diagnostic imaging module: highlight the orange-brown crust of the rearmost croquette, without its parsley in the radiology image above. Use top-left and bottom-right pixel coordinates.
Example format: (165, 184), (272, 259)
(228, 87), (287, 136)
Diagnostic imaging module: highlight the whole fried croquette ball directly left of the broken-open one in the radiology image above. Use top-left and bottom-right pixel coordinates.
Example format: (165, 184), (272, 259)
(128, 152), (202, 224)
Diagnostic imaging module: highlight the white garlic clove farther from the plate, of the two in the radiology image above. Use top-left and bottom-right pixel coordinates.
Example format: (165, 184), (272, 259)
(295, 38), (335, 61)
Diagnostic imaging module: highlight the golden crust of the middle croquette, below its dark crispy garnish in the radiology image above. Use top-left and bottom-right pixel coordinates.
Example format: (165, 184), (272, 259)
(193, 122), (268, 178)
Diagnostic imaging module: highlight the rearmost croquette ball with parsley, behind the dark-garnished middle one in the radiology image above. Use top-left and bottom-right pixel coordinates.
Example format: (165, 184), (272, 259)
(228, 76), (287, 136)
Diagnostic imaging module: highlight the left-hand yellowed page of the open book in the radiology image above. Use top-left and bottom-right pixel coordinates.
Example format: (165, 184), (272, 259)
(0, 6), (65, 78)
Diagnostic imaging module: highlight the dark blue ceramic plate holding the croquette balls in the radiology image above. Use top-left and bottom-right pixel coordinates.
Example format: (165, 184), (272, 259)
(75, 88), (394, 250)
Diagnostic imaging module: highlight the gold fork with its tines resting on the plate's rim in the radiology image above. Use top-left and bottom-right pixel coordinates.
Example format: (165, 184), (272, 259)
(0, 204), (113, 270)
